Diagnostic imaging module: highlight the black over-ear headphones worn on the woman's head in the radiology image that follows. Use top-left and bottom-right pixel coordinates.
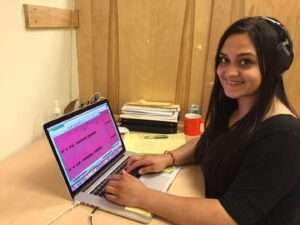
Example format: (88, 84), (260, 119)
(262, 16), (294, 73)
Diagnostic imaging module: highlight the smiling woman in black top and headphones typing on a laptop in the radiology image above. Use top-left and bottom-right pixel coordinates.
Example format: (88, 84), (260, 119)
(106, 17), (300, 225)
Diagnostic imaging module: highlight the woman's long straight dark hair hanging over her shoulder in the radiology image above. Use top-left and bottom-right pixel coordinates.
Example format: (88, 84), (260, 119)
(195, 17), (294, 197)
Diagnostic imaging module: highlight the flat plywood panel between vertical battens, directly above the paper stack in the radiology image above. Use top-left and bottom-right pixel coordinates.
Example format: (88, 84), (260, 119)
(119, 0), (185, 107)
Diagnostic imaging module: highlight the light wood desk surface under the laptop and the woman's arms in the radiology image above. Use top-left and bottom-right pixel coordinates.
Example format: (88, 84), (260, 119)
(0, 137), (203, 225)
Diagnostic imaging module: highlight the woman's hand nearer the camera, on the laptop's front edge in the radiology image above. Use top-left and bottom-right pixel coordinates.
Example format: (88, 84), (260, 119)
(105, 170), (149, 207)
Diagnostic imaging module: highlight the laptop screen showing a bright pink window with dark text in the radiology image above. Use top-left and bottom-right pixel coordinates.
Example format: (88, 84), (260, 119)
(45, 101), (124, 191)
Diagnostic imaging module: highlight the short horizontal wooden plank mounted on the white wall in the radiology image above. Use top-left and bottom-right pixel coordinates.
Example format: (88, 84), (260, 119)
(23, 4), (79, 29)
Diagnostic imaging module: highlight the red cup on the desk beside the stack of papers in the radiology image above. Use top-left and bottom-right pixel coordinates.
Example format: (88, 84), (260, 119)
(183, 113), (202, 136)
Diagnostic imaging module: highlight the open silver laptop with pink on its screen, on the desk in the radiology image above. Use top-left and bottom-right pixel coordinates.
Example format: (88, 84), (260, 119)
(44, 100), (178, 223)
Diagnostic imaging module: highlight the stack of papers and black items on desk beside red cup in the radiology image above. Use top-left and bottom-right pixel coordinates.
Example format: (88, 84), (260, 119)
(120, 100), (180, 134)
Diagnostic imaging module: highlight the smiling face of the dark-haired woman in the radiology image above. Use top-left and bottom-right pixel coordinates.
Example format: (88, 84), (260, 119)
(217, 34), (262, 103)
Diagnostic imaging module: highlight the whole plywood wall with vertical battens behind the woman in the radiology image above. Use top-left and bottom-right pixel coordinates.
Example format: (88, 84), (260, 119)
(76, 0), (300, 116)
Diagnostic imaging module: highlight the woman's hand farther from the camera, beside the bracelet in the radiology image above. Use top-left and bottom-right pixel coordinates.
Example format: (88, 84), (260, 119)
(126, 155), (172, 175)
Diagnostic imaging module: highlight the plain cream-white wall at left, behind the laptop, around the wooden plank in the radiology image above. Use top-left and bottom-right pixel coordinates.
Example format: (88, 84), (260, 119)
(0, 0), (78, 160)
